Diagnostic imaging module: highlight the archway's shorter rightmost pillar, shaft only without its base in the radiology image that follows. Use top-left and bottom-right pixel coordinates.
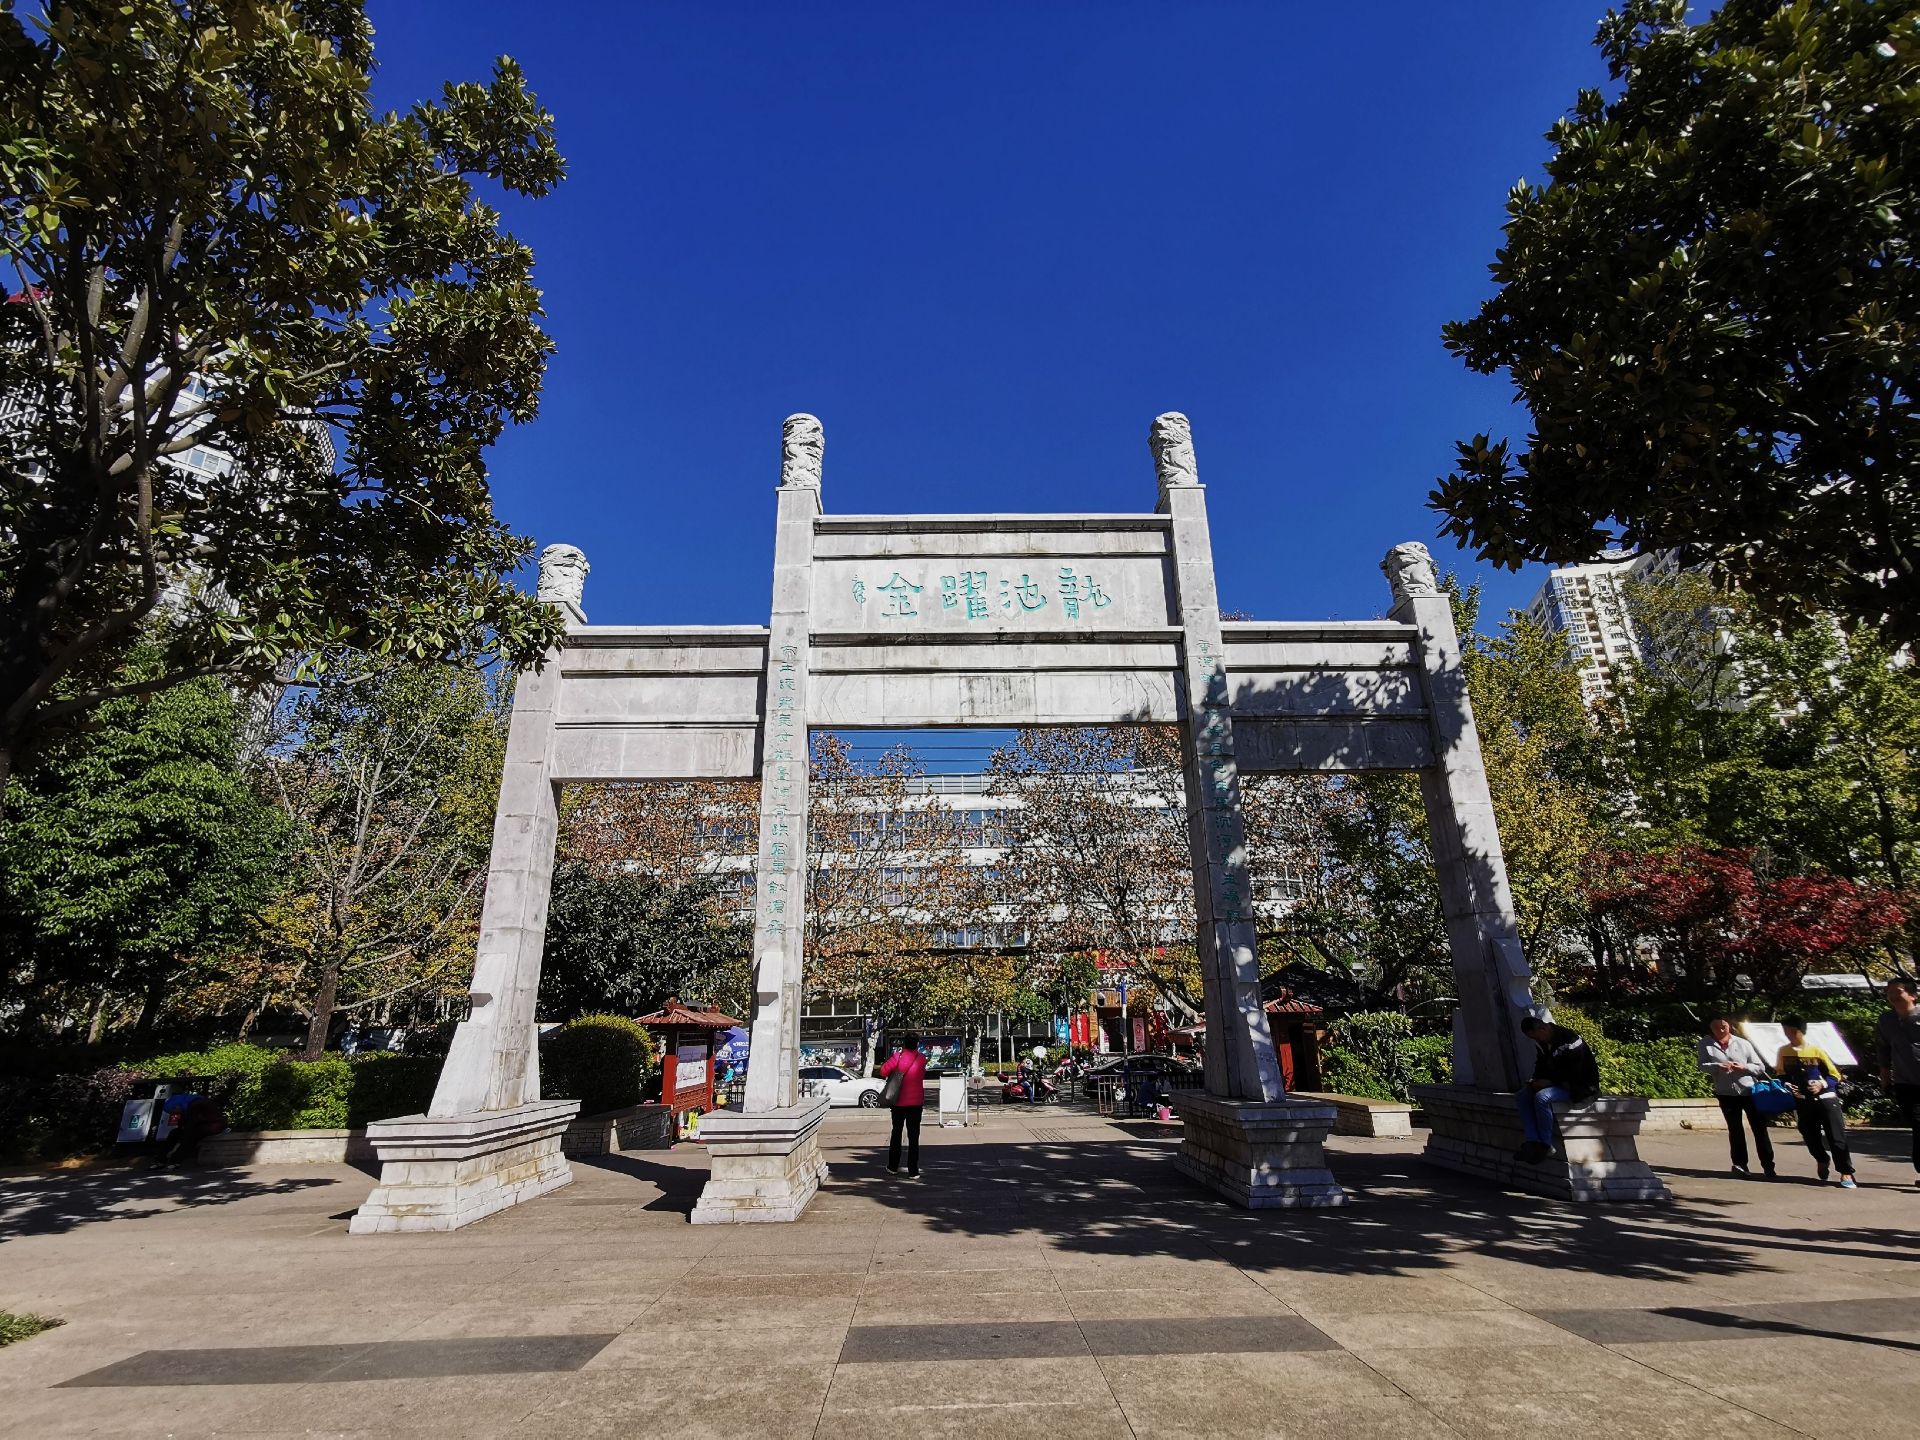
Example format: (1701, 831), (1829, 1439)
(1380, 543), (1532, 1091)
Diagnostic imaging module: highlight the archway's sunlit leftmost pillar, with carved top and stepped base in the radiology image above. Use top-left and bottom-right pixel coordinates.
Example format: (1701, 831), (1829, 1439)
(348, 545), (588, 1235)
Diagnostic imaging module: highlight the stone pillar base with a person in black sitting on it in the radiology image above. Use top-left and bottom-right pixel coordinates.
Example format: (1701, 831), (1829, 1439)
(1413, 1085), (1674, 1200)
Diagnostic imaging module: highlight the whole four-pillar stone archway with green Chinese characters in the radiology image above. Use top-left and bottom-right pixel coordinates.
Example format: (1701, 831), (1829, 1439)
(351, 415), (1665, 1233)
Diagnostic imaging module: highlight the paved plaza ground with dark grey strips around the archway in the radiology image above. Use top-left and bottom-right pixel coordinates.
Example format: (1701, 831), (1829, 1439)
(0, 1110), (1920, 1440)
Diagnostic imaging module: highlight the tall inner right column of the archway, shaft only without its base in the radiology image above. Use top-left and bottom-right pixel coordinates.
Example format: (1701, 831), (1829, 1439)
(1150, 413), (1284, 1100)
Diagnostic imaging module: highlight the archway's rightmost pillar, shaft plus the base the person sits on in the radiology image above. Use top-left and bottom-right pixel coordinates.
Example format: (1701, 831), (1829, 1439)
(1380, 543), (1672, 1200)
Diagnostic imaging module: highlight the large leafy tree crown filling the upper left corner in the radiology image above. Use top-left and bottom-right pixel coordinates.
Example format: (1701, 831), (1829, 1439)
(0, 0), (563, 797)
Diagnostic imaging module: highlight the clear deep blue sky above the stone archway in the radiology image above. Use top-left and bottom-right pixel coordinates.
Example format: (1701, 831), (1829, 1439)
(371, 0), (1605, 624)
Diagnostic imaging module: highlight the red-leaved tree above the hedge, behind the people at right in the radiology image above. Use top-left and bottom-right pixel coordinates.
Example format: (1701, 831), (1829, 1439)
(1592, 845), (1905, 1002)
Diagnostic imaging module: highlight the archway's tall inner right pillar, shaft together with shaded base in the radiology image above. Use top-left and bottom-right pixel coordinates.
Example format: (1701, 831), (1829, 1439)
(1150, 413), (1346, 1208)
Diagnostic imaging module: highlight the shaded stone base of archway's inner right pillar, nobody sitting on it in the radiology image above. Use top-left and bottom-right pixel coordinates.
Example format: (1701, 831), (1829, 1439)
(1173, 1091), (1346, 1210)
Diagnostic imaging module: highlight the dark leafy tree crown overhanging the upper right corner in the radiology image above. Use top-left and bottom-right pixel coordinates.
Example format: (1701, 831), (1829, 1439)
(1432, 0), (1920, 641)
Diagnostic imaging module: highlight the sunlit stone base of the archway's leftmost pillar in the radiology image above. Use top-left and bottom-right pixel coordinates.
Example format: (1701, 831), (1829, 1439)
(348, 1100), (580, 1235)
